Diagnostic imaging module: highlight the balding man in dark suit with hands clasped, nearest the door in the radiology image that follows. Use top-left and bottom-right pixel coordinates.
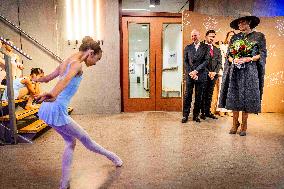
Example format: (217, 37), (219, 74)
(181, 30), (209, 123)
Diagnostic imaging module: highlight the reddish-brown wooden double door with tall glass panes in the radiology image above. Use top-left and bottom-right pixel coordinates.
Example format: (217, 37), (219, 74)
(122, 17), (182, 112)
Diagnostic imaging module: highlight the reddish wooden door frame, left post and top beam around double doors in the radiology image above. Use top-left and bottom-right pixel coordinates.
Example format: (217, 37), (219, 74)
(119, 10), (182, 112)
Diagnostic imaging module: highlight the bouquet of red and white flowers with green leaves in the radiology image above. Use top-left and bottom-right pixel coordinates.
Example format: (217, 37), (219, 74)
(230, 39), (256, 68)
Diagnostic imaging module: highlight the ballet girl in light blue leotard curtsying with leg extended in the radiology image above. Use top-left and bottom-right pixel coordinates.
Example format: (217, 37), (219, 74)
(35, 37), (123, 189)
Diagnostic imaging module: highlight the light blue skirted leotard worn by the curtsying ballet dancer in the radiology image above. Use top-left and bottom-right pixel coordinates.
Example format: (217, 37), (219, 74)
(38, 64), (82, 126)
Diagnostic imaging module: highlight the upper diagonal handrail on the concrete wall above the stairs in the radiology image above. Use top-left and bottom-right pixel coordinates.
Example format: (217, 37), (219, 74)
(0, 14), (63, 63)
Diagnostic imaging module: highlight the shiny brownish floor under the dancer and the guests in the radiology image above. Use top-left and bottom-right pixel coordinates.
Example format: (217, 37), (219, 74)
(0, 112), (284, 189)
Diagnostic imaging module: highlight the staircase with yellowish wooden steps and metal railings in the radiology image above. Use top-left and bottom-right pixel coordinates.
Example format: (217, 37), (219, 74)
(0, 14), (64, 145)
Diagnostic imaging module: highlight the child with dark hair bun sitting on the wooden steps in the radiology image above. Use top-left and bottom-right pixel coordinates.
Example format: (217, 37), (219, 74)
(2, 68), (43, 110)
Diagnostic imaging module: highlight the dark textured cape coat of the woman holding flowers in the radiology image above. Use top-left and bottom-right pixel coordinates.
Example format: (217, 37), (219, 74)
(219, 32), (267, 113)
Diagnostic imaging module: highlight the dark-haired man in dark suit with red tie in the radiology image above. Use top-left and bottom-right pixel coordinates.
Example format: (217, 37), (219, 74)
(200, 30), (222, 119)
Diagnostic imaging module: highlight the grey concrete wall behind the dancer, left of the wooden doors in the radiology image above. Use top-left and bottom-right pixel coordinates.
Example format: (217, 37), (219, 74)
(0, 0), (121, 114)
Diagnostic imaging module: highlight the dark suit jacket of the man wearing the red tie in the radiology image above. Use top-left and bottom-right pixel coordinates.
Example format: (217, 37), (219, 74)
(205, 45), (222, 79)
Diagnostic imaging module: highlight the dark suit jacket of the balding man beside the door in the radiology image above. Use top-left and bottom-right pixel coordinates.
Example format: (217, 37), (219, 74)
(184, 43), (210, 82)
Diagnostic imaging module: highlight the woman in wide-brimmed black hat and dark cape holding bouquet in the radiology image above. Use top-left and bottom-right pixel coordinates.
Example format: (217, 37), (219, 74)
(219, 16), (267, 136)
